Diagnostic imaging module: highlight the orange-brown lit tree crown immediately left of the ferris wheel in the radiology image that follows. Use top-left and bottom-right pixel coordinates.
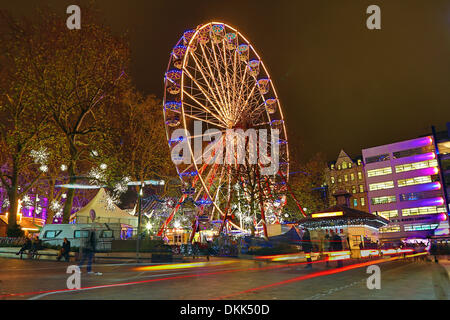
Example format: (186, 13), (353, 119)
(109, 90), (176, 185)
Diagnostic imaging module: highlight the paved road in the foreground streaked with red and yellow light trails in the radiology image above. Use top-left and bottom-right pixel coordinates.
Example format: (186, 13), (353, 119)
(0, 258), (450, 300)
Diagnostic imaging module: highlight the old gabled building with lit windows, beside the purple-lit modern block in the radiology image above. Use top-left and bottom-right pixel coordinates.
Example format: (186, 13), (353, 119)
(325, 150), (369, 212)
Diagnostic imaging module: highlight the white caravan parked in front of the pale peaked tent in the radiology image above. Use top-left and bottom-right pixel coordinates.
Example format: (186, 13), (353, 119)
(39, 223), (121, 252)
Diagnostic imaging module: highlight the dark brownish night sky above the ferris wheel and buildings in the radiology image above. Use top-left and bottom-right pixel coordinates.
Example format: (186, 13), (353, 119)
(0, 0), (450, 160)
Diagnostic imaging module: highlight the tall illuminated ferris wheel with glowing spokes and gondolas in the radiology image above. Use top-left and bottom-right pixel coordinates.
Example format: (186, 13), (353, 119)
(158, 22), (289, 235)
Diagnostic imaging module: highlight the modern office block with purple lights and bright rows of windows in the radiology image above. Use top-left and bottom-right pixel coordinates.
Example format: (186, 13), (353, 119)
(362, 136), (448, 240)
